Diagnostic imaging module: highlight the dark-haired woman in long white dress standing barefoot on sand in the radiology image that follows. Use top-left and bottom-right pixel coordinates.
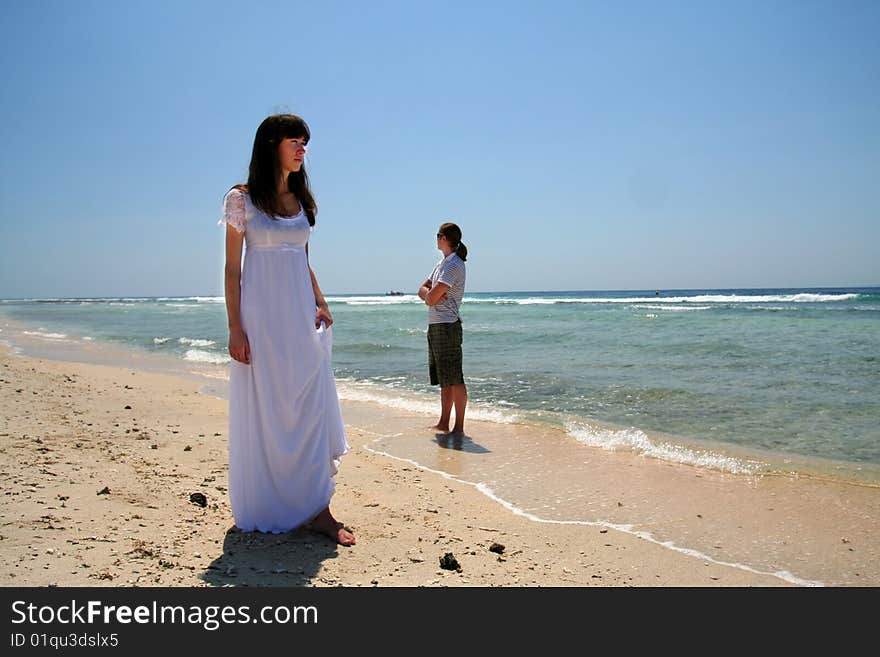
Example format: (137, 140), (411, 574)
(223, 114), (355, 545)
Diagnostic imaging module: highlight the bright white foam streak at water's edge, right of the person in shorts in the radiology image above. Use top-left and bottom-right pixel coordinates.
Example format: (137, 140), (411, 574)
(565, 422), (762, 474)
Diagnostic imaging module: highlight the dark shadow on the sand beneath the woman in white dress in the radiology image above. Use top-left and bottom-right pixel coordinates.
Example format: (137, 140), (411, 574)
(199, 527), (348, 586)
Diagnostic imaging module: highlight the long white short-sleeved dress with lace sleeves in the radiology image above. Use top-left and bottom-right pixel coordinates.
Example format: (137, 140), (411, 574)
(223, 189), (348, 533)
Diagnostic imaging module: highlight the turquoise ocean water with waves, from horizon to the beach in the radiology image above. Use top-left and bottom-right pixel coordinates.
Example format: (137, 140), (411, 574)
(0, 288), (880, 476)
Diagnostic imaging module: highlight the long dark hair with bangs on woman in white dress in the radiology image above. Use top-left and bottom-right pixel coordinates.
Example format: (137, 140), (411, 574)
(247, 114), (318, 226)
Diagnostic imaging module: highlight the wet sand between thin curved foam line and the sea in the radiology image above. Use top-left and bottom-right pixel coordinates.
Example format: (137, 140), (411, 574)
(346, 394), (880, 585)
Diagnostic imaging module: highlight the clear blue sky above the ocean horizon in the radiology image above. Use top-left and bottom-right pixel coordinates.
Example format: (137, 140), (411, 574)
(0, 0), (880, 298)
